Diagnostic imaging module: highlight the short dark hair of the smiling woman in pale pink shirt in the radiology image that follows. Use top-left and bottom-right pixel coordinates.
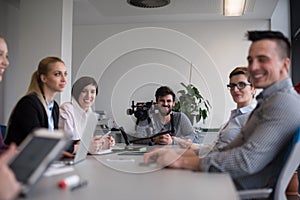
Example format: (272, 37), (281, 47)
(72, 76), (98, 102)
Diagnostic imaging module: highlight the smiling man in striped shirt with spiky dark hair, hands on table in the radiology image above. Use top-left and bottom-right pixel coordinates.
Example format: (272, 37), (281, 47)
(144, 31), (300, 190)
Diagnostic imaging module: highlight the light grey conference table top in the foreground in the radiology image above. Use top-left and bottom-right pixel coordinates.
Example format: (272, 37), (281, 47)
(20, 145), (238, 200)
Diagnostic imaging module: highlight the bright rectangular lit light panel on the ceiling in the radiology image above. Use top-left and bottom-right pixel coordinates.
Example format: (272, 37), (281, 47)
(223, 0), (246, 16)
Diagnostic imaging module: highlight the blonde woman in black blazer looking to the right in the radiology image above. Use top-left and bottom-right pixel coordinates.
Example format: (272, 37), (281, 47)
(5, 57), (67, 145)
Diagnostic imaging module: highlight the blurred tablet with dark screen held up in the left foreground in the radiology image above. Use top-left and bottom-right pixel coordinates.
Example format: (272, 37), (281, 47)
(9, 129), (69, 195)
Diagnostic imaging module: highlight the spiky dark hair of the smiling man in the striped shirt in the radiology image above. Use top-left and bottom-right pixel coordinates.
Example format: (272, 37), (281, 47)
(248, 31), (291, 58)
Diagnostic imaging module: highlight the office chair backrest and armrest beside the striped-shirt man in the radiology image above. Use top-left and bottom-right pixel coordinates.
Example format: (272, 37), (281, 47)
(238, 127), (300, 200)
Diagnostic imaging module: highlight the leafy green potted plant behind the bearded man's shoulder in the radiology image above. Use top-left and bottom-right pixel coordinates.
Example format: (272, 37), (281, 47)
(173, 83), (211, 125)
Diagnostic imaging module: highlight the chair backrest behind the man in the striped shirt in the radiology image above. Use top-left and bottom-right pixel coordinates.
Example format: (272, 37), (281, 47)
(274, 127), (300, 200)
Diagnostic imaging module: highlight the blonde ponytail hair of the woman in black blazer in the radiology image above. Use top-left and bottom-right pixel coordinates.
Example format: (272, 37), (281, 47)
(26, 57), (64, 108)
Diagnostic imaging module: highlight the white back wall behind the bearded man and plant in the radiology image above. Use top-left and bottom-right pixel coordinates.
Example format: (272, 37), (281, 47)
(73, 20), (270, 131)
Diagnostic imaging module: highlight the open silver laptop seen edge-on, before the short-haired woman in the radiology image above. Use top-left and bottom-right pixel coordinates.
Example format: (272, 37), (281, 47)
(60, 113), (98, 165)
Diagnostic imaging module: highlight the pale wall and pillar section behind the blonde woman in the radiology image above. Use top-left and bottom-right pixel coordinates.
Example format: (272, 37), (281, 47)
(0, 0), (73, 124)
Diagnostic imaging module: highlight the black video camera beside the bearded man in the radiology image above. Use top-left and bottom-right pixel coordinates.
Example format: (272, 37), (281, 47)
(127, 101), (154, 121)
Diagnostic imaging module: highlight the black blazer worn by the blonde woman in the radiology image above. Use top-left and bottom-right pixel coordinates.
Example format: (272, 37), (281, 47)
(5, 93), (59, 145)
